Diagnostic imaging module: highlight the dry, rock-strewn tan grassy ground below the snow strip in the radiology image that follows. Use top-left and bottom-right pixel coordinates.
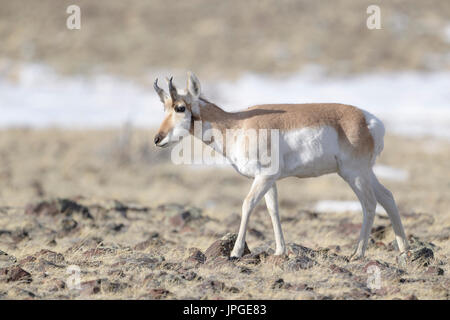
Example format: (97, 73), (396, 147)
(0, 127), (450, 299)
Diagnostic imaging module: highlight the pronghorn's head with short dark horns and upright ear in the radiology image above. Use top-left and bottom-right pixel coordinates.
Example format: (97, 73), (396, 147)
(153, 73), (200, 147)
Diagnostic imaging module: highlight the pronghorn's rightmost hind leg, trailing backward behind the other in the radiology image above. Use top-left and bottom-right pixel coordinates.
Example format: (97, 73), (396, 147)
(371, 172), (408, 252)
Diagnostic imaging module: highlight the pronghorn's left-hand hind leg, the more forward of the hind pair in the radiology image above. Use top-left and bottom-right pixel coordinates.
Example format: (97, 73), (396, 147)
(339, 170), (377, 260)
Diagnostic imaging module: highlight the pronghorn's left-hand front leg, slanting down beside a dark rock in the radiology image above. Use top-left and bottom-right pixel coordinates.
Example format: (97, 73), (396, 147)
(231, 176), (275, 258)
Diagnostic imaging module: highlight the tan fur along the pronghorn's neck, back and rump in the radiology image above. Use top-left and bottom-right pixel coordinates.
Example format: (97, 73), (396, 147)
(200, 100), (374, 154)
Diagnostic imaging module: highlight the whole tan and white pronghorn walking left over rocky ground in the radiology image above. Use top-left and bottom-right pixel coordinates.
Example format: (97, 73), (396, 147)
(154, 73), (408, 259)
